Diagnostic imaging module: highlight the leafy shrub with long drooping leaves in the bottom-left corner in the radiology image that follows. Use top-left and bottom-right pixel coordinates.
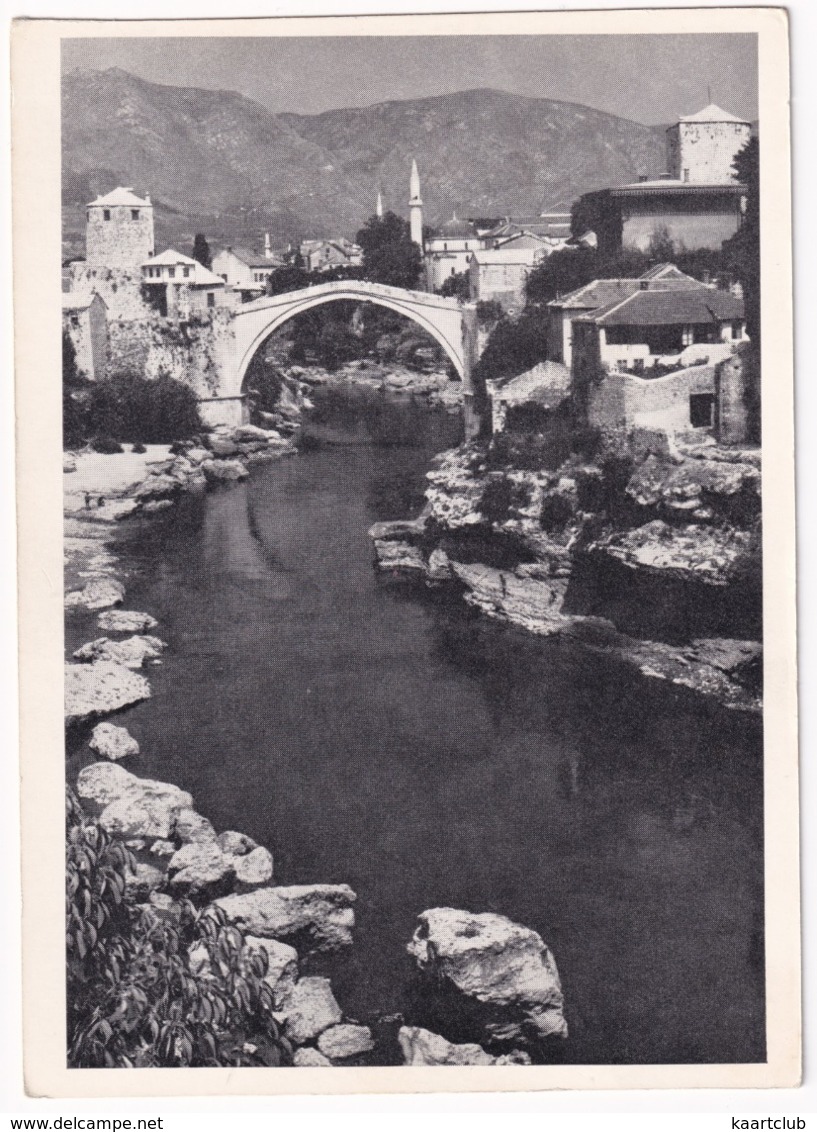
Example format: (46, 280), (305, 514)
(66, 791), (291, 1069)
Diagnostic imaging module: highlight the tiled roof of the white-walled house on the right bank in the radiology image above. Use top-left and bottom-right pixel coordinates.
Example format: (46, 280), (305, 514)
(578, 288), (743, 326)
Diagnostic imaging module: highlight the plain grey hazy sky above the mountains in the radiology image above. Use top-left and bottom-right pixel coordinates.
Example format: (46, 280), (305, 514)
(62, 35), (757, 125)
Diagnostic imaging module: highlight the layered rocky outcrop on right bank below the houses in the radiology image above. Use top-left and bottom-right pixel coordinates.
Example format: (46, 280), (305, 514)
(369, 437), (762, 711)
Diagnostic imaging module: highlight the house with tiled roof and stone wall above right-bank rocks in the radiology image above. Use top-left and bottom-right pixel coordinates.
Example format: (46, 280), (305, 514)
(571, 286), (747, 432)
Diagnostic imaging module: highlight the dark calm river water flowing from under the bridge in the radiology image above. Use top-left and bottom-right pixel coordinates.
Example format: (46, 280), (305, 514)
(69, 393), (764, 1064)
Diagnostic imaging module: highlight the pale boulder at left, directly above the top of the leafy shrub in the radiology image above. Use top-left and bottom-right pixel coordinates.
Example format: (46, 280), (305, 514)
(77, 763), (192, 840)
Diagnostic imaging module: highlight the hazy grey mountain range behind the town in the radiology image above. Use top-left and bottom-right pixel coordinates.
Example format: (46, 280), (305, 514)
(62, 68), (665, 255)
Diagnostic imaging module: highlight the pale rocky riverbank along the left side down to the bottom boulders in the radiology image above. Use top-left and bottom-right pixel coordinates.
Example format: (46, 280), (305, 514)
(66, 412), (567, 1067)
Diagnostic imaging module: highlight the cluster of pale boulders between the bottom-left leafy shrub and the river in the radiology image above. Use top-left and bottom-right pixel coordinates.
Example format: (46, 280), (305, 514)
(76, 762), (375, 1066)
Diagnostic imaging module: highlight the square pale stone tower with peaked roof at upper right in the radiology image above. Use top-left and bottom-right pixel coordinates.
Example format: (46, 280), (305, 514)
(667, 103), (751, 185)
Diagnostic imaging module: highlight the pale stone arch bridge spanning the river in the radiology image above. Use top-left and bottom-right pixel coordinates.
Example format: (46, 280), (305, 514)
(200, 280), (480, 431)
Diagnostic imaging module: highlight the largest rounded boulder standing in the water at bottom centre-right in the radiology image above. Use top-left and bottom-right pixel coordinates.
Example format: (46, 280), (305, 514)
(409, 908), (567, 1043)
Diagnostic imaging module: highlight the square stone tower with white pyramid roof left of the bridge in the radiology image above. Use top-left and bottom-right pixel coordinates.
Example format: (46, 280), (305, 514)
(85, 188), (154, 277)
